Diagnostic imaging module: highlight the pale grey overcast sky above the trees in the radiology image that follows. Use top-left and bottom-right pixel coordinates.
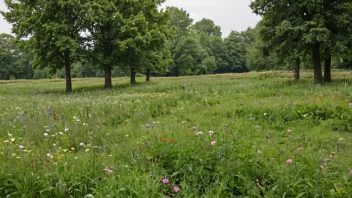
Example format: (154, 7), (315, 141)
(0, 0), (260, 37)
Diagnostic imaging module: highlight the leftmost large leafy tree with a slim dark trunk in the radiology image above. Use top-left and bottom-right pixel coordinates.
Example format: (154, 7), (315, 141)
(2, 0), (84, 92)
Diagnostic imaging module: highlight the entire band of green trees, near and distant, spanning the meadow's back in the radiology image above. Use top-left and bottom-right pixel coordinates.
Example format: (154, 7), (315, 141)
(0, 0), (351, 92)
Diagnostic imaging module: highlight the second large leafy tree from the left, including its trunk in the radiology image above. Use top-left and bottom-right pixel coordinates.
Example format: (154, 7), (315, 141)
(84, 0), (169, 85)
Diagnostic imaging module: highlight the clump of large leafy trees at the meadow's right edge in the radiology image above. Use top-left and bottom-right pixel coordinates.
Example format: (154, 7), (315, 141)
(250, 0), (352, 84)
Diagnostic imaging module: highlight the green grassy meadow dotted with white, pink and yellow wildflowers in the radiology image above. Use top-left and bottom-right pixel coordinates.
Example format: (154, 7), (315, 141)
(0, 72), (352, 198)
